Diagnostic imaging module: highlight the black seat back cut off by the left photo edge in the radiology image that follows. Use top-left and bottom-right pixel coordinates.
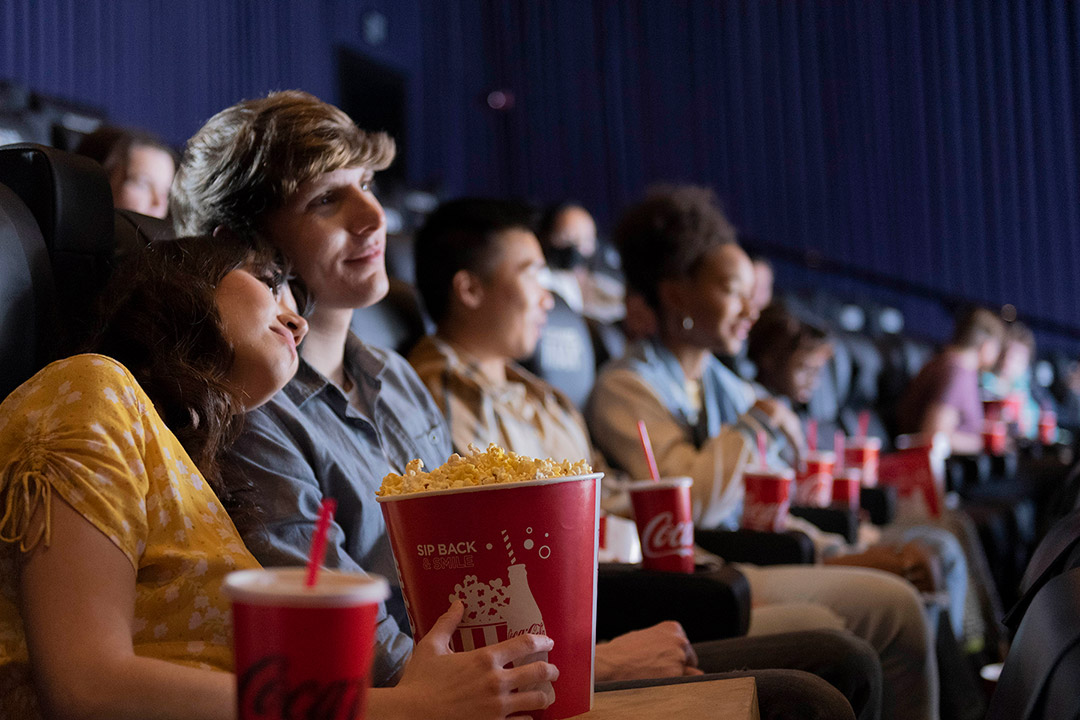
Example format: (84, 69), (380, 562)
(0, 179), (56, 400)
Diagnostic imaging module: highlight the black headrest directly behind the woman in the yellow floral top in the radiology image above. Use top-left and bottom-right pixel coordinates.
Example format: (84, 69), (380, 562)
(0, 144), (116, 352)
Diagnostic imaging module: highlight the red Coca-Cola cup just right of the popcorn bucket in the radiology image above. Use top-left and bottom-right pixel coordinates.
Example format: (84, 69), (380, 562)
(627, 477), (693, 572)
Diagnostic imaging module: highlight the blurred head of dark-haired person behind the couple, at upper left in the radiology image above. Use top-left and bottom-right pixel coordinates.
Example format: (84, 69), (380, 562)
(76, 125), (176, 218)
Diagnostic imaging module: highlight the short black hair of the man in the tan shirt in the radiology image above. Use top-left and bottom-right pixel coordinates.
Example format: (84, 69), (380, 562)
(413, 198), (536, 325)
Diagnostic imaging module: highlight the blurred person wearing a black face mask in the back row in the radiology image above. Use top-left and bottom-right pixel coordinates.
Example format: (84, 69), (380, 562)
(538, 203), (625, 322)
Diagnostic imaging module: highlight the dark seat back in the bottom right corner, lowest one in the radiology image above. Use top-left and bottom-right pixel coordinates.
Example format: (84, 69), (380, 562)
(986, 569), (1080, 720)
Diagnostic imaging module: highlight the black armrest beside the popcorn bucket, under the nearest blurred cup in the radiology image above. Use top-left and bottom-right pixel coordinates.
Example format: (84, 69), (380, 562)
(596, 562), (750, 642)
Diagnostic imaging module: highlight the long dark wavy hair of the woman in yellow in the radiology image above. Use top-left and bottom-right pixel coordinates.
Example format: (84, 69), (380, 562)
(87, 235), (287, 526)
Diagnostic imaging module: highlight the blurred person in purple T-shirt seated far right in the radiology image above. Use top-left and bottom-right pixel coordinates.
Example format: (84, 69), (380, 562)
(897, 308), (1005, 454)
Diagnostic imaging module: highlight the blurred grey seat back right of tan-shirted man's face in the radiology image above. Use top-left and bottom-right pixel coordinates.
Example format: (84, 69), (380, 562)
(523, 294), (596, 408)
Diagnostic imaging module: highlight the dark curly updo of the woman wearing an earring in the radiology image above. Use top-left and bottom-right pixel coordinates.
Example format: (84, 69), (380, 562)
(613, 186), (735, 310)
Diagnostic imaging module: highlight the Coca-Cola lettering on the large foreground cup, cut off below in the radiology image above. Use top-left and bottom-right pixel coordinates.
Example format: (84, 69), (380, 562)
(237, 655), (367, 720)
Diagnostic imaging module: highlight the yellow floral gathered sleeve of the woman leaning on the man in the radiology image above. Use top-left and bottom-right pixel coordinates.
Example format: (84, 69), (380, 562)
(0, 355), (154, 568)
